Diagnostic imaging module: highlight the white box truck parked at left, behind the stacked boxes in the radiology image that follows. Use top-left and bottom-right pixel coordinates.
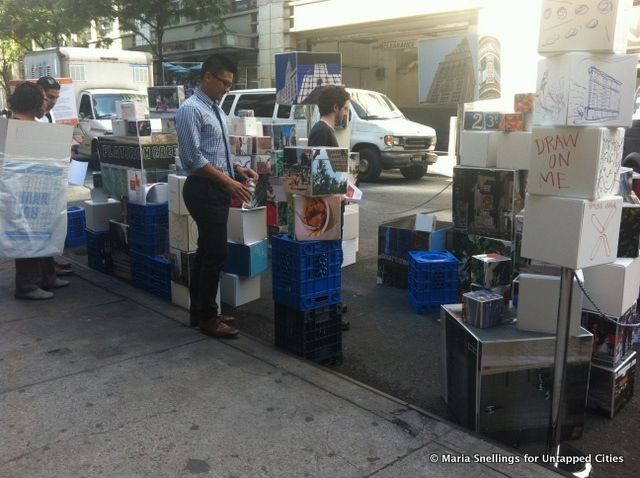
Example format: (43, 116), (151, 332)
(24, 47), (153, 165)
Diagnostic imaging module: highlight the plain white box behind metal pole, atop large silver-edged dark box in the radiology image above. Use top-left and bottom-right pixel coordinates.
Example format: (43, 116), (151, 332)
(516, 271), (582, 337)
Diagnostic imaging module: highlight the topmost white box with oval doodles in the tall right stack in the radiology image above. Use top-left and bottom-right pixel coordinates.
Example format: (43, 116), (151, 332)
(539, 0), (616, 51)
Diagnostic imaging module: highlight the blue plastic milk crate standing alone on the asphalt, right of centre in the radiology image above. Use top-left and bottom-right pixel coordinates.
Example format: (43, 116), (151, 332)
(409, 251), (459, 314)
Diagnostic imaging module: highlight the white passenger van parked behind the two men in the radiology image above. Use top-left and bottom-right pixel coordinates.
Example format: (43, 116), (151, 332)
(220, 88), (438, 181)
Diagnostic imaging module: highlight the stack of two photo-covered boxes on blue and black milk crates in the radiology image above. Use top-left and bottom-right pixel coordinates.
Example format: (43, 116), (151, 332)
(271, 143), (350, 364)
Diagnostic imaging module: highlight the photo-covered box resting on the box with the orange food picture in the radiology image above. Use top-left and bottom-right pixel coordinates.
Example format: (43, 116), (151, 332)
(283, 147), (349, 196)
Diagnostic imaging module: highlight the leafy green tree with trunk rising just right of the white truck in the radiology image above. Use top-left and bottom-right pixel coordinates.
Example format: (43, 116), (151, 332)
(114, 0), (228, 81)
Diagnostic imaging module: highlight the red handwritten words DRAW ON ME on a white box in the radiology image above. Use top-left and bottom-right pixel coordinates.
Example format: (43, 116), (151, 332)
(535, 131), (580, 189)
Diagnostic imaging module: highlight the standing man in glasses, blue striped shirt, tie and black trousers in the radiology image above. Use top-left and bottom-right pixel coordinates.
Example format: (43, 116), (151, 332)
(176, 55), (258, 338)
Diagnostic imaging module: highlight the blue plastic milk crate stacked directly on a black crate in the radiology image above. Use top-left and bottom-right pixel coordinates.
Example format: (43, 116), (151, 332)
(271, 235), (342, 311)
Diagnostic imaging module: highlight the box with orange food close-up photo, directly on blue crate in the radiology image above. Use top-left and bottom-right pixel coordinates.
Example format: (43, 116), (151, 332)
(293, 195), (342, 241)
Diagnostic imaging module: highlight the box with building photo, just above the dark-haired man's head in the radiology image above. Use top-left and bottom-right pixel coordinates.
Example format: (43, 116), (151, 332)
(275, 51), (342, 105)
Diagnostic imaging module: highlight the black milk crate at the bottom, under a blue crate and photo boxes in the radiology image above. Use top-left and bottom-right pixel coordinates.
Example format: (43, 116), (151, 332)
(274, 302), (342, 365)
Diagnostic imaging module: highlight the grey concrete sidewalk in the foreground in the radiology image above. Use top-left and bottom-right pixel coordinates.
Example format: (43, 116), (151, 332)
(0, 260), (557, 478)
